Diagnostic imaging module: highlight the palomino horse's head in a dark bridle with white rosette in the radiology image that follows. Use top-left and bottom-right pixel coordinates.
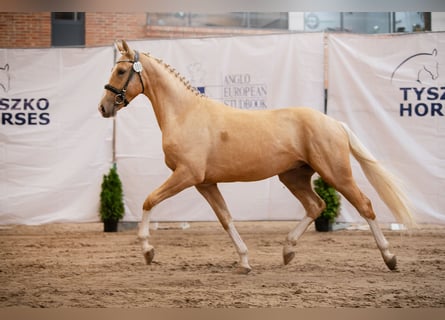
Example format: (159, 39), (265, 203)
(99, 41), (145, 118)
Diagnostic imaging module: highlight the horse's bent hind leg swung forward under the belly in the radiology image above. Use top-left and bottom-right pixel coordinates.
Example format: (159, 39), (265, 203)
(279, 165), (326, 264)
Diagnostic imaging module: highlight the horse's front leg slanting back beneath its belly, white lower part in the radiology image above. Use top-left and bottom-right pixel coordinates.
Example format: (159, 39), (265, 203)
(196, 184), (252, 274)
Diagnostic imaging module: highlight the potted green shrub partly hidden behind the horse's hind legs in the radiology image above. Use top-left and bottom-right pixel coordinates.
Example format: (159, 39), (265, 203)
(314, 177), (341, 232)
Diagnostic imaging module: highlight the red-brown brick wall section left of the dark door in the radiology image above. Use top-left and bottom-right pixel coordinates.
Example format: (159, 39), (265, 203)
(0, 12), (51, 48)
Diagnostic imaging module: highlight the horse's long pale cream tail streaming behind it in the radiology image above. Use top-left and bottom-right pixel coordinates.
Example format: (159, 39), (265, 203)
(341, 122), (416, 227)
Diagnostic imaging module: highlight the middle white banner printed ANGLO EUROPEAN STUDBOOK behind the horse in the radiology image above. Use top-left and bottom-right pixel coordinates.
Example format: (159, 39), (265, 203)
(117, 34), (324, 221)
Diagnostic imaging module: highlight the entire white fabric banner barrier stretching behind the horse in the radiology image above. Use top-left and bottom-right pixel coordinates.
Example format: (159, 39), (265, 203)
(0, 33), (445, 224)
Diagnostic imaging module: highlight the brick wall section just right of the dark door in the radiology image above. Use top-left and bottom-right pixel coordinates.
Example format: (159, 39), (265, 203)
(85, 12), (147, 46)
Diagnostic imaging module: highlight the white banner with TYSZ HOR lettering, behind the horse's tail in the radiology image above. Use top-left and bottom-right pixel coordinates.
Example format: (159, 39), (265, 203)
(328, 33), (445, 223)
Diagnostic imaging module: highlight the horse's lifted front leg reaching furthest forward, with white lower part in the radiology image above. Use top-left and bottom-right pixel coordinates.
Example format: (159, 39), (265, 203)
(138, 168), (196, 264)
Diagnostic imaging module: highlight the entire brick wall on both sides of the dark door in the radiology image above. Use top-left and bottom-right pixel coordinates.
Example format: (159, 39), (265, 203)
(0, 12), (283, 48)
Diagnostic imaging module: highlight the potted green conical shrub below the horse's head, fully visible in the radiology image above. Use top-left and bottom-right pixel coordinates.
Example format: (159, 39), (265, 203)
(99, 165), (125, 232)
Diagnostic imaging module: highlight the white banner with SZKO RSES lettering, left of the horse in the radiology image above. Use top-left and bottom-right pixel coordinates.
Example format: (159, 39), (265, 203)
(0, 47), (114, 224)
